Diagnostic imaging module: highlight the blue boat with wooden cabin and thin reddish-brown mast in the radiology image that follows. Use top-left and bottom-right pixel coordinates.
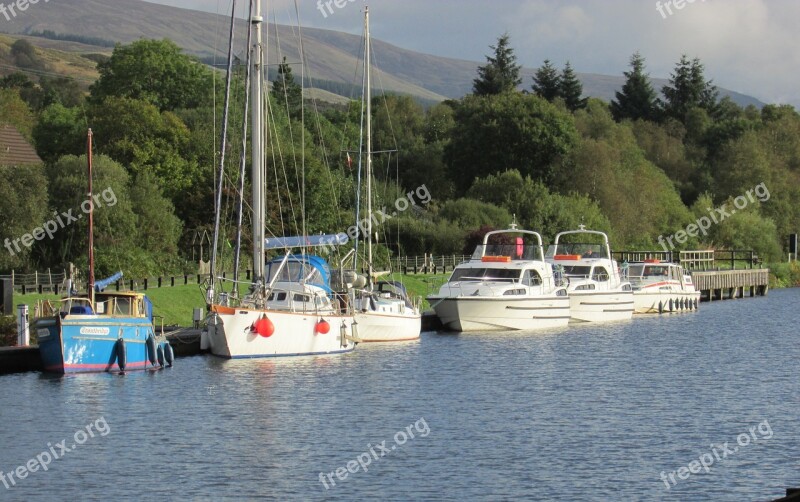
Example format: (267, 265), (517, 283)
(33, 129), (174, 374)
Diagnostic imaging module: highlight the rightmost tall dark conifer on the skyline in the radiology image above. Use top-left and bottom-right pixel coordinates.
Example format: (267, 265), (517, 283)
(661, 54), (719, 122)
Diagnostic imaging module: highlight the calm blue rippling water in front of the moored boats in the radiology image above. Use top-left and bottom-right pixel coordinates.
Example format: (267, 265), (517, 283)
(0, 289), (800, 501)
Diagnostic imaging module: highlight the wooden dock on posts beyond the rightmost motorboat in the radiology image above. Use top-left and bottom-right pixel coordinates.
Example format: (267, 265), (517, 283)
(691, 268), (769, 301)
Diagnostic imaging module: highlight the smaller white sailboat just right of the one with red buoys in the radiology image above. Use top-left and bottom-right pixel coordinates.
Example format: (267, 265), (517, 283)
(354, 6), (422, 342)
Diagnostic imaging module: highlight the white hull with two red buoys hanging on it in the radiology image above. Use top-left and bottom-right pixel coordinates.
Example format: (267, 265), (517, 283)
(208, 308), (355, 359)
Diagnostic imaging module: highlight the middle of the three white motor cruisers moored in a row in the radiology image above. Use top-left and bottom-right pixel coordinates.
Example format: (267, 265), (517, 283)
(547, 225), (633, 322)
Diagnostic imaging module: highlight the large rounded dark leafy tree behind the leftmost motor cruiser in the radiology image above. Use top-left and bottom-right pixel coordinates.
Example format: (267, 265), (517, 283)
(445, 93), (577, 193)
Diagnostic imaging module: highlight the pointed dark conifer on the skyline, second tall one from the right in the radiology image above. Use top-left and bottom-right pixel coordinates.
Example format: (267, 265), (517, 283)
(611, 52), (658, 122)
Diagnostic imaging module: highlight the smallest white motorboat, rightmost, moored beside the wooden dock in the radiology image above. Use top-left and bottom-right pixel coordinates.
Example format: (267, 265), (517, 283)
(627, 259), (700, 314)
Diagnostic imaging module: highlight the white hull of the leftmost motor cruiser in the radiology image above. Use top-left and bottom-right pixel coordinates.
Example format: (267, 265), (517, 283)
(430, 295), (569, 331)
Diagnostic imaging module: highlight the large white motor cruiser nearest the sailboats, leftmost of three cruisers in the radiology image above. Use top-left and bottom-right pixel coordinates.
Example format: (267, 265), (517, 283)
(428, 225), (570, 331)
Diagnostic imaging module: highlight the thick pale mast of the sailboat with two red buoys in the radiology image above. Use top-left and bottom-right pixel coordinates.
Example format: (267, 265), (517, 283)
(250, 0), (264, 282)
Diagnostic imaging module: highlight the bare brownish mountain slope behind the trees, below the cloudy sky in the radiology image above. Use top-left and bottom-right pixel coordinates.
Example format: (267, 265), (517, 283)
(0, 0), (764, 107)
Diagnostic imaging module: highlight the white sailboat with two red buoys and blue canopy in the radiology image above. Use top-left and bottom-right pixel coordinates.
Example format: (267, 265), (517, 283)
(201, 0), (358, 358)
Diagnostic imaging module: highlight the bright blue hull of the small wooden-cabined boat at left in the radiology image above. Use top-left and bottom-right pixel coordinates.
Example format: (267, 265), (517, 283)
(33, 316), (155, 374)
